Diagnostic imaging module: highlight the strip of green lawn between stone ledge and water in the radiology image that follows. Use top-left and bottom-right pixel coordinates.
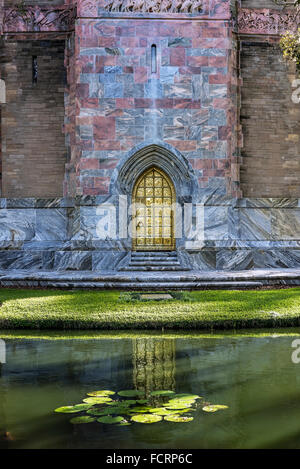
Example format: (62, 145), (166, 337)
(0, 288), (300, 330)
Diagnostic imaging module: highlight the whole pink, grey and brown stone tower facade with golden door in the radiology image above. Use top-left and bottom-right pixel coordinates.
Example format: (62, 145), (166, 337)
(0, 0), (300, 271)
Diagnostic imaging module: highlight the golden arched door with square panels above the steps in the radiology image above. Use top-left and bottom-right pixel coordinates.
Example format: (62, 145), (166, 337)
(133, 168), (175, 251)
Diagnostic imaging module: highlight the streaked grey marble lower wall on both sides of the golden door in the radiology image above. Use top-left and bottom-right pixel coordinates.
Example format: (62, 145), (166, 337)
(0, 192), (300, 271)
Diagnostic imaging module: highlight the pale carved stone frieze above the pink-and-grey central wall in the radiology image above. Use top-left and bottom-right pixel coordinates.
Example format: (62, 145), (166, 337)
(104, 0), (203, 13)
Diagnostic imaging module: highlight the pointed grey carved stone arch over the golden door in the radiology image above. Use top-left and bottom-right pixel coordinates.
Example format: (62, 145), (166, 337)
(111, 142), (198, 203)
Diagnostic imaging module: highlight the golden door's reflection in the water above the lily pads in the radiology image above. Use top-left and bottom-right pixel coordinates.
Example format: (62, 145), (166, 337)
(133, 338), (176, 394)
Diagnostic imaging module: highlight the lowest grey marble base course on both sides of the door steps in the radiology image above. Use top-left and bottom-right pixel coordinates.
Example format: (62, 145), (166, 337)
(0, 248), (300, 272)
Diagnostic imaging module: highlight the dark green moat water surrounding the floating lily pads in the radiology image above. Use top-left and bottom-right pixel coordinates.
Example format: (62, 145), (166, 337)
(0, 329), (300, 449)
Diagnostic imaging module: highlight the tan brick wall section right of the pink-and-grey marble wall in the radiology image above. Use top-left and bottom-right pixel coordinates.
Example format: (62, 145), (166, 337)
(241, 42), (300, 197)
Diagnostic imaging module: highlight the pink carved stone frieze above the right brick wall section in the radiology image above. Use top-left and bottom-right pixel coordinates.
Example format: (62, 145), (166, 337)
(238, 8), (299, 34)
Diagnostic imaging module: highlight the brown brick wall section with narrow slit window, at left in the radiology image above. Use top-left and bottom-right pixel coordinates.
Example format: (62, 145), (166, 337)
(1, 41), (66, 197)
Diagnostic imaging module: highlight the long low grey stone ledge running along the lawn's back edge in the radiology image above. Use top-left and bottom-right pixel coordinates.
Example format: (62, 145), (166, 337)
(0, 268), (300, 291)
